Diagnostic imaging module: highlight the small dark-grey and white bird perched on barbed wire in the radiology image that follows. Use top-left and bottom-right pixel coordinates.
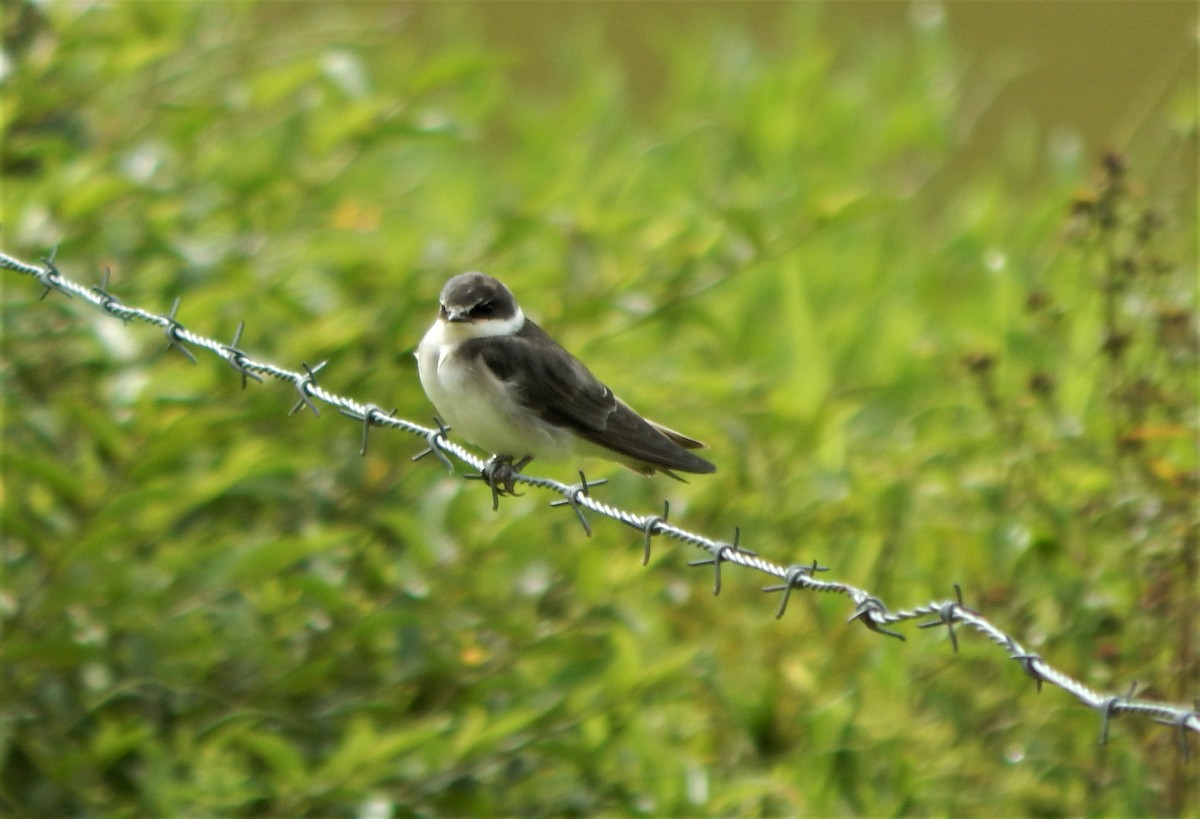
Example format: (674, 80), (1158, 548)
(415, 273), (716, 494)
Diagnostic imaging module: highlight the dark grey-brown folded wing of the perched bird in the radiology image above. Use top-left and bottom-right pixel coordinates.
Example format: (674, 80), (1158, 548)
(463, 321), (716, 472)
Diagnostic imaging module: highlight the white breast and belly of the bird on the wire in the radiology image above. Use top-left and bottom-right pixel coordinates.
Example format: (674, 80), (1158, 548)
(416, 321), (576, 461)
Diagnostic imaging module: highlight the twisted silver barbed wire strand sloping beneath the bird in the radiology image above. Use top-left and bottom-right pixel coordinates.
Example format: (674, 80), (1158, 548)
(0, 247), (1200, 759)
